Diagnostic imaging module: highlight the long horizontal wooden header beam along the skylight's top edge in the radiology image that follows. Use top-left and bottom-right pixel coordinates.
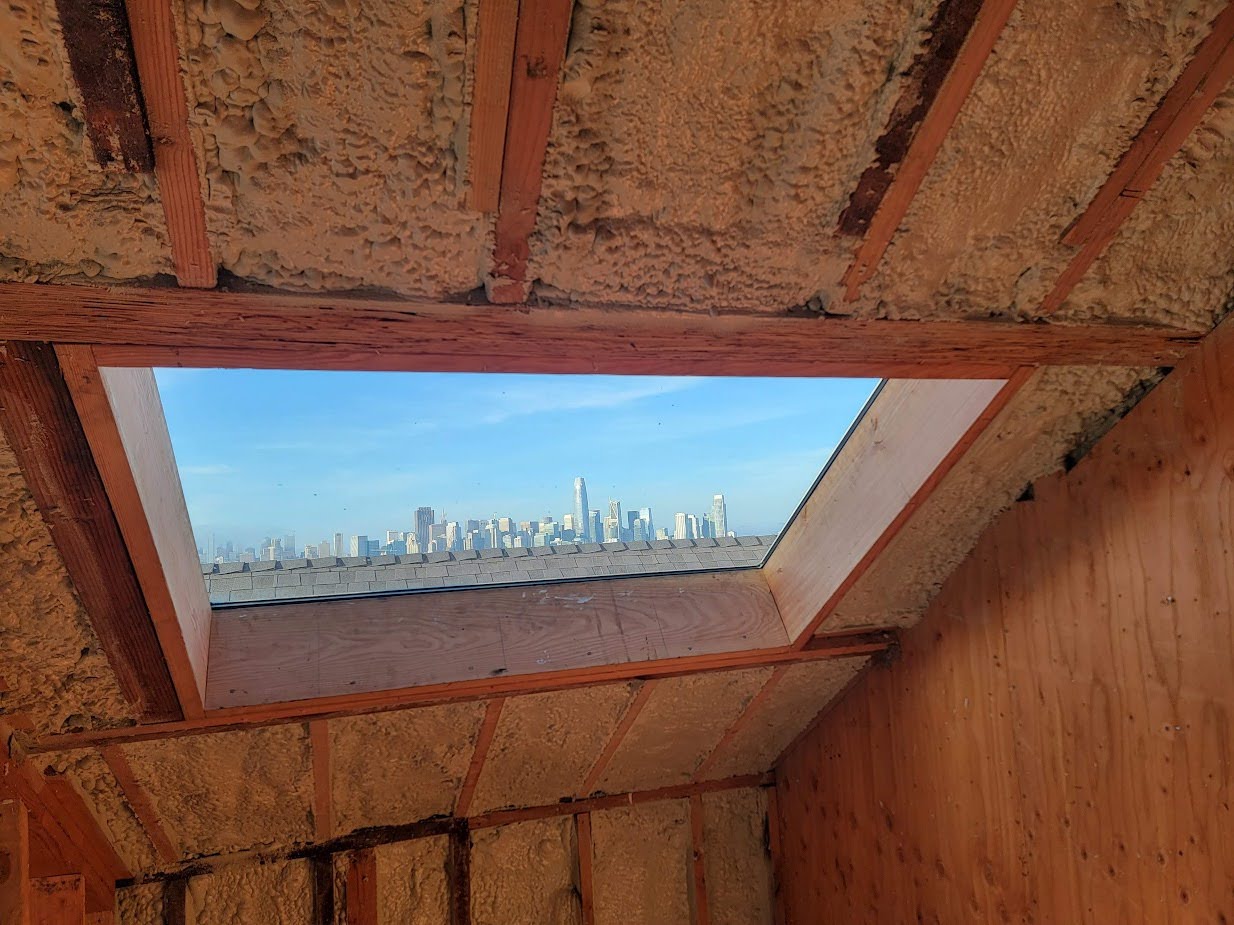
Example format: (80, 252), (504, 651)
(0, 282), (1202, 379)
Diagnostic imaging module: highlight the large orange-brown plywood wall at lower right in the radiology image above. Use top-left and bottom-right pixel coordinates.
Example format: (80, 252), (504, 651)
(777, 323), (1234, 923)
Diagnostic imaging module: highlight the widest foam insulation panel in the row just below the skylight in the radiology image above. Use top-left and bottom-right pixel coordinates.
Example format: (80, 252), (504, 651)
(120, 723), (312, 857)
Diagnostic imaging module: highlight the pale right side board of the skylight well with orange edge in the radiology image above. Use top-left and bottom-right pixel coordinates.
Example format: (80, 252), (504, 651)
(763, 380), (1018, 645)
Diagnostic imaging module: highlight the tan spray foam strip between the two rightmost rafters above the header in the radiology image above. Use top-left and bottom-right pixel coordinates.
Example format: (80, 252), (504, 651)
(853, 0), (1224, 317)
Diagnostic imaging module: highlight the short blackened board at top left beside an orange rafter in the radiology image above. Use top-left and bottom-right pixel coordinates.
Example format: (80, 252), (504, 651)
(56, 0), (154, 173)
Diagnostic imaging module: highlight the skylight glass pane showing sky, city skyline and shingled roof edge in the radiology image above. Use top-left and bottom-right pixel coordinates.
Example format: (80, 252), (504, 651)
(155, 369), (877, 606)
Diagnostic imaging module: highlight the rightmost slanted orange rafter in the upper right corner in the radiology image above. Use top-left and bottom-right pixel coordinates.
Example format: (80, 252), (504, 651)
(1040, 4), (1234, 315)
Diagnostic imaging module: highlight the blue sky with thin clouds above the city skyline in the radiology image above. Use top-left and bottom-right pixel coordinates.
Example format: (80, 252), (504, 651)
(157, 370), (876, 545)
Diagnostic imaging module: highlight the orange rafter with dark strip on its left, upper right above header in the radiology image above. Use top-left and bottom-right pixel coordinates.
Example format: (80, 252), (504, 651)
(843, 0), (1016, 302)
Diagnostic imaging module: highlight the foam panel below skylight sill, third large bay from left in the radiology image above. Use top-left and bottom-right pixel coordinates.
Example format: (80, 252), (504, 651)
(470, 685), (634, 813)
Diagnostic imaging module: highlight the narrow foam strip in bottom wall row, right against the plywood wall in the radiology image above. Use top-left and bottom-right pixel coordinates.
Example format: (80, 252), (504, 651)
(702, 788), (774, 925)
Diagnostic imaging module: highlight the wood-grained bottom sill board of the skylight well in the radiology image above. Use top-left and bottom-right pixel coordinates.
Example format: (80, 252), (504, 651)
(206, 571), (787, 709)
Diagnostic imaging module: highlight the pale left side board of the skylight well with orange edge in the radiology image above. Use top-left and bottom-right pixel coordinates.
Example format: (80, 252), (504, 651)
(56, 345), (211, 718)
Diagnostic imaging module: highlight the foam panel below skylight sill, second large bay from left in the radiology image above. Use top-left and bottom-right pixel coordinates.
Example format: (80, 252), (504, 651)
(329, 702), (485, 834)
